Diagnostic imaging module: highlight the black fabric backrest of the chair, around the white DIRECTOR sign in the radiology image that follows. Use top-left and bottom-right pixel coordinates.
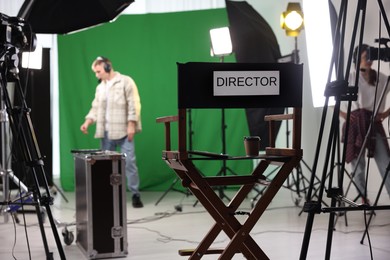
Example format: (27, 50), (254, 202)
(178, 62), (303, 109)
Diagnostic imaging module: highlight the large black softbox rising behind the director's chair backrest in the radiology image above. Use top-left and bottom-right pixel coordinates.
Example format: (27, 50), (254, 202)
(226, 1), (284, 150)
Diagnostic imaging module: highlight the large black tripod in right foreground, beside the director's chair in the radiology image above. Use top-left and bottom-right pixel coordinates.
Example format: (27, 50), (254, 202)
(300, 0), (390, 259)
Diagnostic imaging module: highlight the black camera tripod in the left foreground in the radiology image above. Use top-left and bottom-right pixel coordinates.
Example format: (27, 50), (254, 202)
(0, 44), (66, 260)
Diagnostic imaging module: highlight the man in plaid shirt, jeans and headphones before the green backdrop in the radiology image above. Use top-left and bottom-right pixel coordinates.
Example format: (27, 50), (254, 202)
(80, 57), (143, 208)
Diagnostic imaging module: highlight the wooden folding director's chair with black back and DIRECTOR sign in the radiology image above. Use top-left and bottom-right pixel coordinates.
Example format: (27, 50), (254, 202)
(156, 62), (303, 259)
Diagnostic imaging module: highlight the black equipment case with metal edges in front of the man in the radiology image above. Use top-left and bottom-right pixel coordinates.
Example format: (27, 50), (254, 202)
(72, 150), (128, 259)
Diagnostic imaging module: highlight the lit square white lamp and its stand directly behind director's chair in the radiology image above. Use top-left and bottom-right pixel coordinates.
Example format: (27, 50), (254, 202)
(210, 27), (236, 200)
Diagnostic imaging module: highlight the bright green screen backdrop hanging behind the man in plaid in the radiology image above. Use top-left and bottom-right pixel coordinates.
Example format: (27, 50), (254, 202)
(58, 9), (252, 191)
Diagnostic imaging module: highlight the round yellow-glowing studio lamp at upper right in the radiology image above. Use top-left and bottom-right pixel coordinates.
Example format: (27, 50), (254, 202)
(280, 3), (304, 37)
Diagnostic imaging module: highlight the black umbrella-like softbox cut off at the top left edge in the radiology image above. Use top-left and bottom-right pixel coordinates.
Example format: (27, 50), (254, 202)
(18, 0), (134, 34)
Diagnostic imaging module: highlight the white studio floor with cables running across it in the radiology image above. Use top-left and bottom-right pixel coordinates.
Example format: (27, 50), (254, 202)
(0, 182), (390, 260)
